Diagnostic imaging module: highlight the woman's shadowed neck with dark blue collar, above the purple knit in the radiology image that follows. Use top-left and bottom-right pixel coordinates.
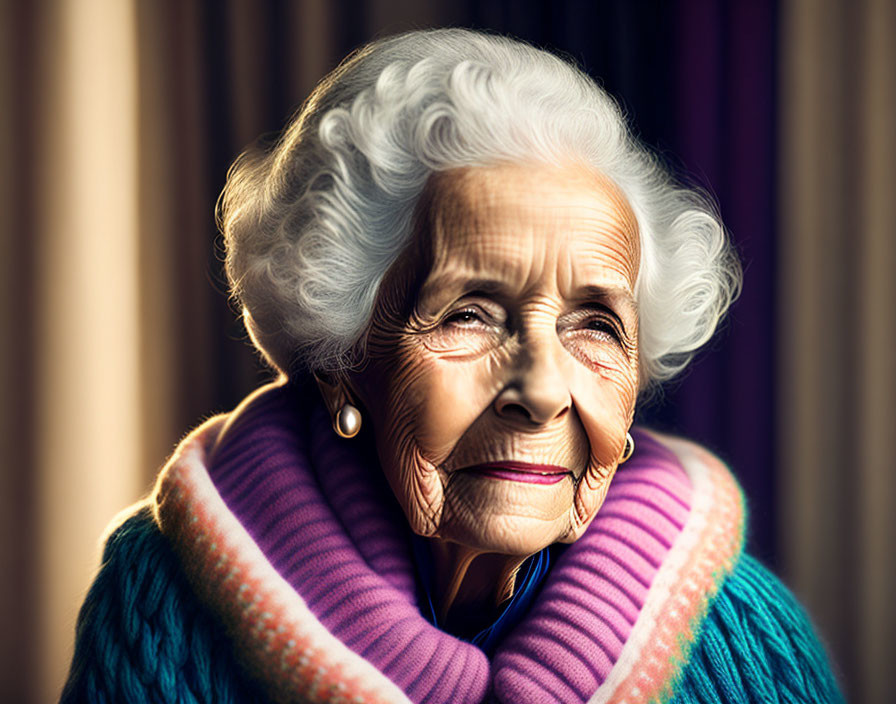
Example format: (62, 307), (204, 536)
(429, 539), (528, 636)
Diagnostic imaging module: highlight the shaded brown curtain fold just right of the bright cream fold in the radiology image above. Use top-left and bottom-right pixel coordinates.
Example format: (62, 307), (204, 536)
(135, 2), (221, 478)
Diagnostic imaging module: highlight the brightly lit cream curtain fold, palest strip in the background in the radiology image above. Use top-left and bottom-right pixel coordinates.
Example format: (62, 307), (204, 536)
(29, 0), (142, 701)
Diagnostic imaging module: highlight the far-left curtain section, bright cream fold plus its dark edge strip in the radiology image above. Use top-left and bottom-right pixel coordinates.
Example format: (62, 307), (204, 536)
(0, 2), (139, 701)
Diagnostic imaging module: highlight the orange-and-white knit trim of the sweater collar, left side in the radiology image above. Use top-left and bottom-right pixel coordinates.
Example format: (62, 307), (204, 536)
(153, 417), (409, 704)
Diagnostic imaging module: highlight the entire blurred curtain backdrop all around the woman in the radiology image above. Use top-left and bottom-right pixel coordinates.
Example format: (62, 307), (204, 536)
(0, 0), (896, 704)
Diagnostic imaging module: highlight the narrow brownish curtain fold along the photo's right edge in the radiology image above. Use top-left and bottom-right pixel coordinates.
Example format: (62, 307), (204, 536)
(856, 0), (896, 703)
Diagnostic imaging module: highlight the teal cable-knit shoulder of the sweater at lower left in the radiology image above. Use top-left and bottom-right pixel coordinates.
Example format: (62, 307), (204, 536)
(62, 505), (264, 704)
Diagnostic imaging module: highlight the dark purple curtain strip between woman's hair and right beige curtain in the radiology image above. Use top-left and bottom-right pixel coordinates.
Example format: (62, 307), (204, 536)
(662, 0), (778, 564)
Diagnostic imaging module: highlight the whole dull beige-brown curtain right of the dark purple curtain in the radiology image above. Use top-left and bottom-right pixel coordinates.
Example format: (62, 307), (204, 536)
(779, 0), (896, 704)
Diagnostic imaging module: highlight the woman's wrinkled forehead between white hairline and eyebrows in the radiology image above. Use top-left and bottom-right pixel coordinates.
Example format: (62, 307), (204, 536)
(421, 166), (639, 310)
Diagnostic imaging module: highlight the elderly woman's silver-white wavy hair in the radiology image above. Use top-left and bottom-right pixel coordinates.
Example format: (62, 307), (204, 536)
(219, 29), (741, 388)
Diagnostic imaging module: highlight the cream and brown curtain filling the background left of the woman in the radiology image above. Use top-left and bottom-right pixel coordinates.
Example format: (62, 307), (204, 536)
(0, 0), (451, 704)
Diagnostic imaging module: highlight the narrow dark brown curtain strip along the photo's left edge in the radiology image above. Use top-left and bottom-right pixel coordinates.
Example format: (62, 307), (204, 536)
(0, 0), (40, 704)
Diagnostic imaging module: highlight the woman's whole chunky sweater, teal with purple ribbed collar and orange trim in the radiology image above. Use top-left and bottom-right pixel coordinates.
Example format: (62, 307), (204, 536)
(63, 388), (838, 702)
